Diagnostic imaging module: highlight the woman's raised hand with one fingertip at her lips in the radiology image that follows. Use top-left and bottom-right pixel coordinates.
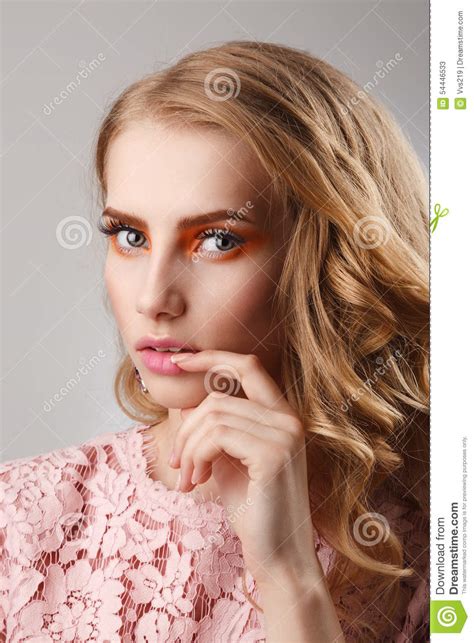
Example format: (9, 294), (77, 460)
(167, 350), (322, 583)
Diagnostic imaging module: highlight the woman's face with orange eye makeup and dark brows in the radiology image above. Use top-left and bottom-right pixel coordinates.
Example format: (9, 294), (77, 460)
(102, 122), (289, 408)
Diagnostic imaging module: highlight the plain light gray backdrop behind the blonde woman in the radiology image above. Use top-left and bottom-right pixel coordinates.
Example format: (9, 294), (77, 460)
(0, 0), (429, 461)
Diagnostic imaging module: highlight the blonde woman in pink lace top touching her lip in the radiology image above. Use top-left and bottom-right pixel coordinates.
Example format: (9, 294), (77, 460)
(0, 42), (429, 643)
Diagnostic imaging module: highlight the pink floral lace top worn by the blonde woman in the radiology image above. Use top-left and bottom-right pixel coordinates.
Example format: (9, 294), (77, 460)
(0, 425), (428, 643)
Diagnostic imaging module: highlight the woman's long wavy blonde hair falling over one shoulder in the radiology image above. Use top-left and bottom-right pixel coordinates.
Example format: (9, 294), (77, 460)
(95, 41), (429, 641)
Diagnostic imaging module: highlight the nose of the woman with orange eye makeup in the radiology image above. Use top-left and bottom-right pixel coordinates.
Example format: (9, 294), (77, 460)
(136, 247), (187, 319)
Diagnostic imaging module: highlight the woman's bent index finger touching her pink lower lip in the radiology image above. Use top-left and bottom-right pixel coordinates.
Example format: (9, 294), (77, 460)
(171, 349), (289, 412)
